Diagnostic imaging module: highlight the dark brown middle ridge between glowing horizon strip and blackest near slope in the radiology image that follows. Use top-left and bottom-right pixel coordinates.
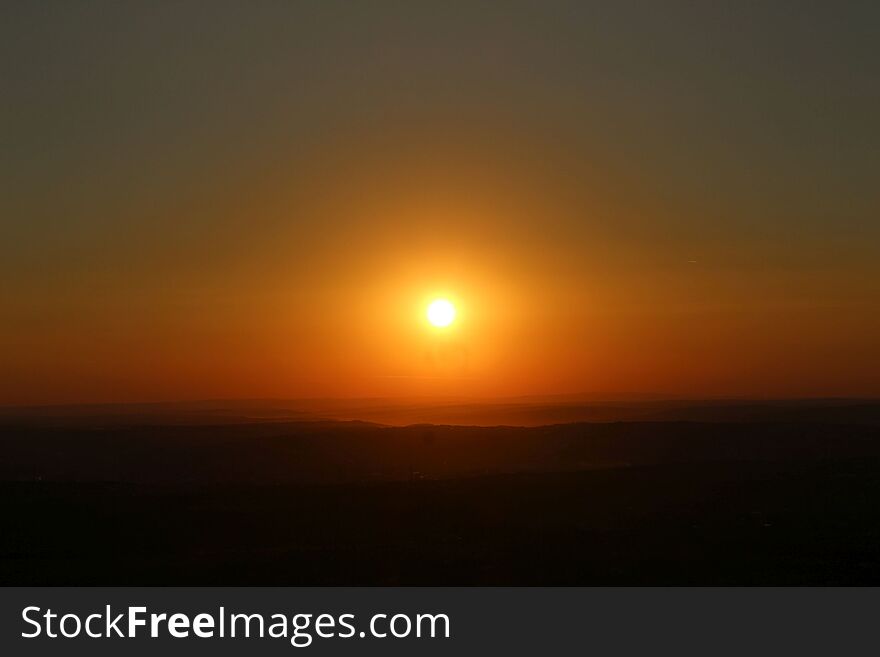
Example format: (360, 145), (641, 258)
(0, 422), (880, 484)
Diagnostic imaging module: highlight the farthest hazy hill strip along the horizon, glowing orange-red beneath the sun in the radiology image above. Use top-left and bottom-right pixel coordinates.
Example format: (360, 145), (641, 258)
(0, 395), (880, 428)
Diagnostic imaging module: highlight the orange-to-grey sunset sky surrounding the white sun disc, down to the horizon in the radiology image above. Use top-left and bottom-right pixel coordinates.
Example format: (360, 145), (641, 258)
(0, 0), (880, 404)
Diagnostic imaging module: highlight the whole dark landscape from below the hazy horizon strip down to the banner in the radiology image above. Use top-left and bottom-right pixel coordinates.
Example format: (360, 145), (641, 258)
(0, 403), (880, 585)
